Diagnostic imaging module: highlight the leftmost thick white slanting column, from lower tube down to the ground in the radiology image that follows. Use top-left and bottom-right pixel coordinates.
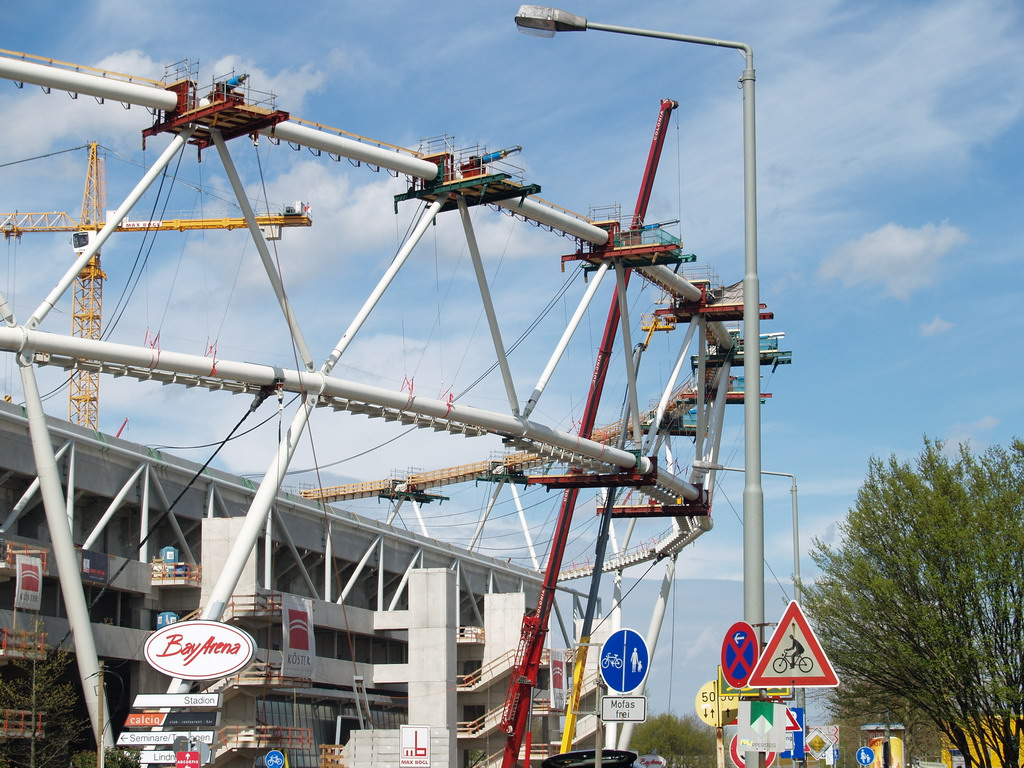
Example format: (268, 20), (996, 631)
(17, 360), (114, 746)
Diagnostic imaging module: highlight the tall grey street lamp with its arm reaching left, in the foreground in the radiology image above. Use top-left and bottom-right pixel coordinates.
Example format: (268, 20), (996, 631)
(515, 5), (765, 627)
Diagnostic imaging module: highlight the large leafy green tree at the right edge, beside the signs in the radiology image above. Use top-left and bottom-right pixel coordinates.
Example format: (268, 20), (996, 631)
(804, 438), (1024, 768)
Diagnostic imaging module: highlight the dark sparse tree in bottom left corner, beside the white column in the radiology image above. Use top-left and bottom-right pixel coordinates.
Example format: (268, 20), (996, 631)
(0, 649), (88, 768)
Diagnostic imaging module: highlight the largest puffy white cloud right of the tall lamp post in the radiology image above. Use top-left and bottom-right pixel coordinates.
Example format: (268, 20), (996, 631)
(819, 221), (967, 299)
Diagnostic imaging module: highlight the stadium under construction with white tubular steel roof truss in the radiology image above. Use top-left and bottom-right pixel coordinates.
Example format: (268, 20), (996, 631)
(0, 46), (790, 768)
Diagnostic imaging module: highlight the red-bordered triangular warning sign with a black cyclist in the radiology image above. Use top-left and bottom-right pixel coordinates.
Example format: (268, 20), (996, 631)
(746, 601), (839, 688)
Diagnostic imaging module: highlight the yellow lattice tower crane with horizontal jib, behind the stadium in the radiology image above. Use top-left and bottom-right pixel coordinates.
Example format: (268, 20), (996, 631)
(0, 141), (312, 429)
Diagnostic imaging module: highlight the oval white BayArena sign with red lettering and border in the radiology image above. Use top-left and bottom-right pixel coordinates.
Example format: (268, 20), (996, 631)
(143, 620), (256, 680)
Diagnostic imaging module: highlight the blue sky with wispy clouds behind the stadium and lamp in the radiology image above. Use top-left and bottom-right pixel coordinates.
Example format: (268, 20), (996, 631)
(0, 0), (1024, 711)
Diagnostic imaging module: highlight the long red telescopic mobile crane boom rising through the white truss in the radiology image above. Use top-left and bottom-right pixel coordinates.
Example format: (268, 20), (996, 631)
(500, 98), (679, 768)
